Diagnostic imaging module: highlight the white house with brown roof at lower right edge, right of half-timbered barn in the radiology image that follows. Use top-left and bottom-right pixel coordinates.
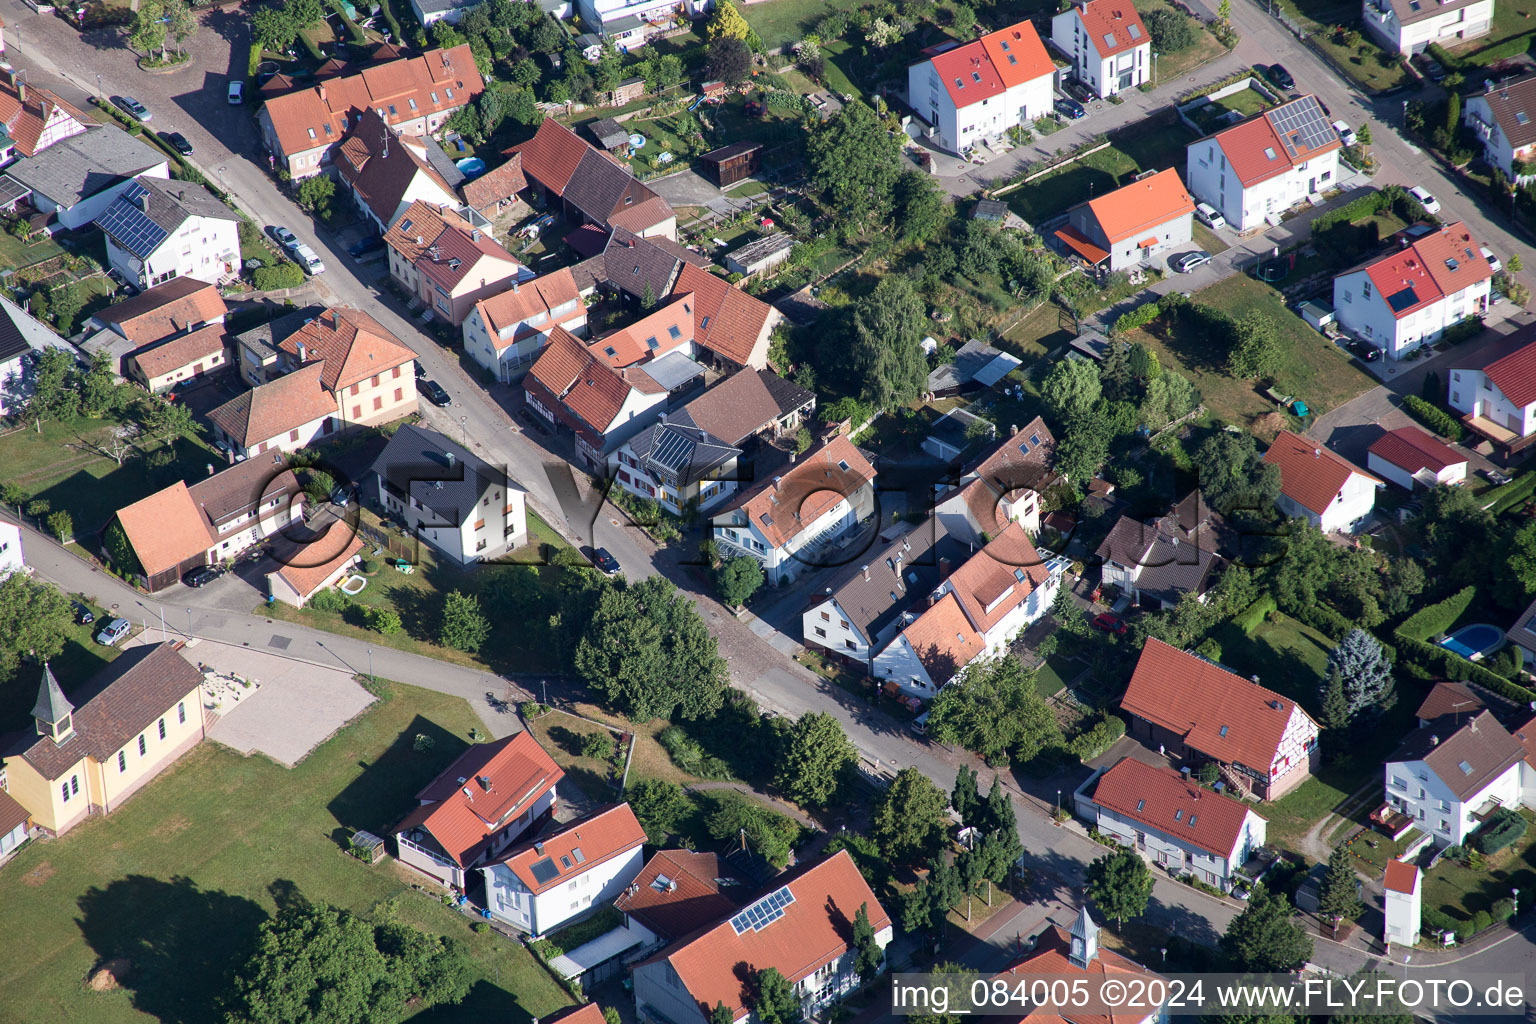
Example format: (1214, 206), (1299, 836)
(1384, 711), (1536, 846)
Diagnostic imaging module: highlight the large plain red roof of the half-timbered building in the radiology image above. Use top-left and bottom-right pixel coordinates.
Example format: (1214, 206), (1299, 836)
(1120, 639), (1306, 775)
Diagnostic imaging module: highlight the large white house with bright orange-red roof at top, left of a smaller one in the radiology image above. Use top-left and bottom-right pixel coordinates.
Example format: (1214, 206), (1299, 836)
(906, 21), (1055, 154)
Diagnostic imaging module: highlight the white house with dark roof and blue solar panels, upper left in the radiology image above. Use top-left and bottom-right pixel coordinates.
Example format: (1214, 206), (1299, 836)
(95, 175), (240, 289)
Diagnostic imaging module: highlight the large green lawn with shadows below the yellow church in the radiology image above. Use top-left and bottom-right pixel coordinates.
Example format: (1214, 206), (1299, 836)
(0, 685), (570, 1024)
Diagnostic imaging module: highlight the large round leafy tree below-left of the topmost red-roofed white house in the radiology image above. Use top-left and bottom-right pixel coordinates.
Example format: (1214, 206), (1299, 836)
(805, 100), (902, 229)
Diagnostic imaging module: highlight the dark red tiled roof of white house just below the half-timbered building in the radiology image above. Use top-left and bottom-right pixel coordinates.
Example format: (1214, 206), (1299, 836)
(1094, 757), (1249, 857)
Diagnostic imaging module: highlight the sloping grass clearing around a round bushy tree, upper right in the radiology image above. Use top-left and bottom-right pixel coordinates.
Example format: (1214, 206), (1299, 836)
(1129, 275), (1376, 427)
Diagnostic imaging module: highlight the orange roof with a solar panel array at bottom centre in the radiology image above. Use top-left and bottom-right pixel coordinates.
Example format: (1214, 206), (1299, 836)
(660, 851), (891, 1019)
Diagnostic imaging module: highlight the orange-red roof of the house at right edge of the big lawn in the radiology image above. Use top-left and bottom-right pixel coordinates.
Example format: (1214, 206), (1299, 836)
(395, 732), (565, 867)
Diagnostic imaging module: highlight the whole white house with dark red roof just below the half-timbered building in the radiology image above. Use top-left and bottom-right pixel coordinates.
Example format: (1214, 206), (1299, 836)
(1074, 757), (1269, 889)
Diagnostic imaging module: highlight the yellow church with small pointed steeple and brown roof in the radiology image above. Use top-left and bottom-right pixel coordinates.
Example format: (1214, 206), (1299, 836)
(0, 642), (206, 835)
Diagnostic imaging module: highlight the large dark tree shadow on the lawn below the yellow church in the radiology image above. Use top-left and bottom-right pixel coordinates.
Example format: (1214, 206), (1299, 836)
(75, 875), (267, 1024)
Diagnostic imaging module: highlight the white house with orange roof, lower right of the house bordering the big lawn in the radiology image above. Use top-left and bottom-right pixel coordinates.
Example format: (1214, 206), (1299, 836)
(479, 803), (645, 936)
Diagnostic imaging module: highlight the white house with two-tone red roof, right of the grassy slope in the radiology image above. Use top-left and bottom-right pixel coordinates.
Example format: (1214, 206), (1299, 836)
(1333, 221), (1493, 359)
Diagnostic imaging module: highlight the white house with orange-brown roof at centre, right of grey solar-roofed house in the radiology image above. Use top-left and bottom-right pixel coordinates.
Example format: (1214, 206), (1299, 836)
(713, 434), (876, 586)
